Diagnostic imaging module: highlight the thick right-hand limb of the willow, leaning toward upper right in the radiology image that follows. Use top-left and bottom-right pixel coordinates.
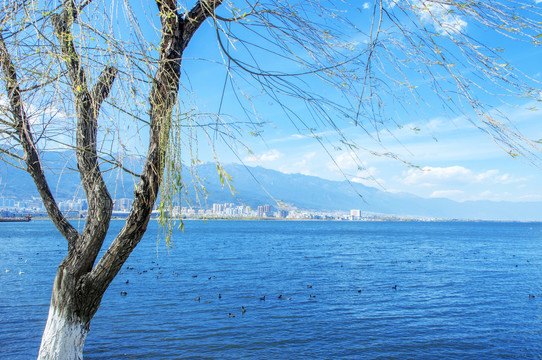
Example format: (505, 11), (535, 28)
(89, 0), (222, 300)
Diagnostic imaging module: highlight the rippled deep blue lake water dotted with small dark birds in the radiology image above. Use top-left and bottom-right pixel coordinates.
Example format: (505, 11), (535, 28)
(0, 221), (542, 360)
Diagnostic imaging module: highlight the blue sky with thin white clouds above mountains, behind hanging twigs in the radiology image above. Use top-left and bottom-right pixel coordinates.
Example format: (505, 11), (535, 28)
(5, 0), (542, 201)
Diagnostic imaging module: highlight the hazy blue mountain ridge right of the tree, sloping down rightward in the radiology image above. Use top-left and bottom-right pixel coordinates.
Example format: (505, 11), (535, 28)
(189, 164), (542, 221)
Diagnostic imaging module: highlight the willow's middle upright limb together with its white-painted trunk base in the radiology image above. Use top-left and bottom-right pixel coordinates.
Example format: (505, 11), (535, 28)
(39, 1), (121, 359)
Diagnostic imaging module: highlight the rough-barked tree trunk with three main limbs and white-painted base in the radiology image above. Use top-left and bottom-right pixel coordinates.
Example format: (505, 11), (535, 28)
(0, 0), (222, 360)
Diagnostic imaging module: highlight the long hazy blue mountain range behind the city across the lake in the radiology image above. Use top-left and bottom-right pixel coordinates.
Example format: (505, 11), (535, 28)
(0, 153), (542, 221)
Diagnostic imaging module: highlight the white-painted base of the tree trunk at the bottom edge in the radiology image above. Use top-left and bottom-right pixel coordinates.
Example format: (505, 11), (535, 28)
(38, 305), (88, 360)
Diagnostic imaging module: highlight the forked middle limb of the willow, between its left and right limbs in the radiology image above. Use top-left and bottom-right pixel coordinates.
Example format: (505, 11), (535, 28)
(52, 0), (117, 271)
